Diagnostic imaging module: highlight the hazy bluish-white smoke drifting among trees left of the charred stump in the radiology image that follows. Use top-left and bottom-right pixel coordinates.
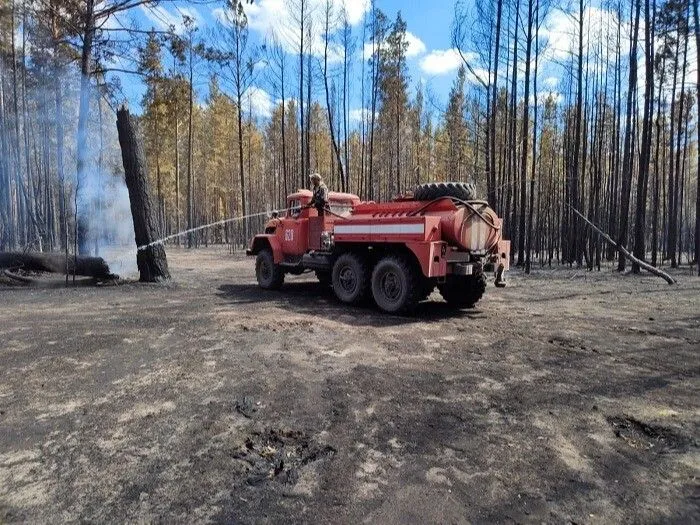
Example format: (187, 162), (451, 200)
(0, 52), (143, 277)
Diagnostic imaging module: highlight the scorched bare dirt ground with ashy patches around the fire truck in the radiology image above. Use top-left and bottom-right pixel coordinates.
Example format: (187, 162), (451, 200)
(0, 249), (700, 524)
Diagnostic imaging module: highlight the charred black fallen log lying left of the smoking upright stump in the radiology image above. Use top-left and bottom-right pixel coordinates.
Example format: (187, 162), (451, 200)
(0, 252), (114, 279)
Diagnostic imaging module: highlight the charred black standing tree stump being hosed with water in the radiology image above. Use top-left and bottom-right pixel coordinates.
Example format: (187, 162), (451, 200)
(117, 107), (170, 282)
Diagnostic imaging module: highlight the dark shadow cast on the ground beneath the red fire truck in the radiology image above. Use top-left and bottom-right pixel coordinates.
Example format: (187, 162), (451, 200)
(216, 281), (486, 327)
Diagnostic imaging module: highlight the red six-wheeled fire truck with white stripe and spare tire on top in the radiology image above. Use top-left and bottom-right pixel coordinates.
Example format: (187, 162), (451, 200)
(246, 183), (510, 313)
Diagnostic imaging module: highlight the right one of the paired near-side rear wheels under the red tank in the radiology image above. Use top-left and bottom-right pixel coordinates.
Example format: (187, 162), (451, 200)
(372, 255), (423, 314)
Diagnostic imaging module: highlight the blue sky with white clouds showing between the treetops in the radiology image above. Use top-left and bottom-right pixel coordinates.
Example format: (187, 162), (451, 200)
(112, 0), (656, 122)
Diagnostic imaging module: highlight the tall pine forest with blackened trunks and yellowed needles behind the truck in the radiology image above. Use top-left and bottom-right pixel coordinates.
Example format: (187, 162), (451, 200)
(0, 0), (700, 272)
